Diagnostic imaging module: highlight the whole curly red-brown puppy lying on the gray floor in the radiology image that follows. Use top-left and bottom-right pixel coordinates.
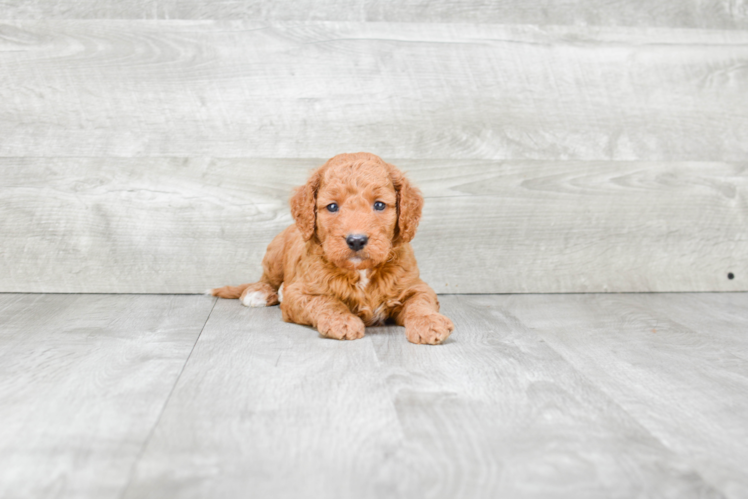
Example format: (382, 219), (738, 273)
(208, 153), (454, 344)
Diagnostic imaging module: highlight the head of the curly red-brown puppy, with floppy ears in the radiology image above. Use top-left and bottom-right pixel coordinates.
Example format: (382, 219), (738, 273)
(291, 153), (423, 269)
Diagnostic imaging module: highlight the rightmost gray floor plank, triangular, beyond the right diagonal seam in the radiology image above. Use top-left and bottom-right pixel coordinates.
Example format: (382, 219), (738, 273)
(500, 294), (748, 498)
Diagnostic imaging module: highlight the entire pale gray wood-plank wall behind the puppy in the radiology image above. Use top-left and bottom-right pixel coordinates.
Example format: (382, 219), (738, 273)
(0, 0), (748, 293)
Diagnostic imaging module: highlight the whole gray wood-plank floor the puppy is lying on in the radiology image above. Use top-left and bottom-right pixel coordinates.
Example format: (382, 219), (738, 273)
(0, 293), (748, 498)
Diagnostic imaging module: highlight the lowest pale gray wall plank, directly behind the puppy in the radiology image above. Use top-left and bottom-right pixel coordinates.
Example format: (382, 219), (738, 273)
(0, 158), (748, 293)
